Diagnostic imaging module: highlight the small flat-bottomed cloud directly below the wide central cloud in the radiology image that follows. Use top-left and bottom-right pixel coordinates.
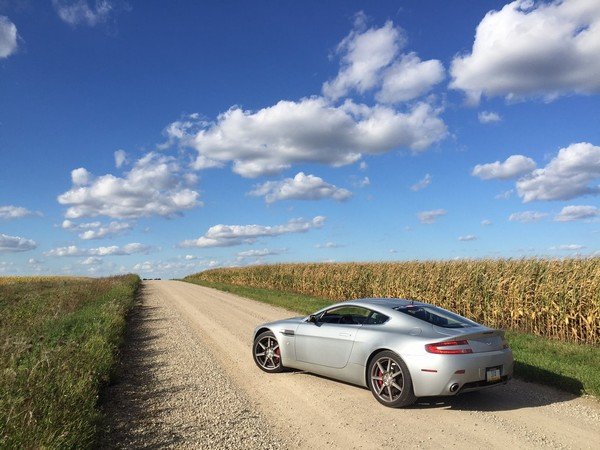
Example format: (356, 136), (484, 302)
(249, 172), (352, 203)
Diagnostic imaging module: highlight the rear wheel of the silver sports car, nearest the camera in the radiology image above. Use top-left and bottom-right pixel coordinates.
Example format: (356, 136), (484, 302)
(368, 350), (417, 408)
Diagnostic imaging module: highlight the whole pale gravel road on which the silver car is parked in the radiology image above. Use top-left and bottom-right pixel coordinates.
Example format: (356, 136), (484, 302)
(101, 281), (600, 449)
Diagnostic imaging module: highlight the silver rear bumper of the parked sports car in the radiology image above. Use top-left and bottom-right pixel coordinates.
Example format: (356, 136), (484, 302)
(404, 349), (514, 397)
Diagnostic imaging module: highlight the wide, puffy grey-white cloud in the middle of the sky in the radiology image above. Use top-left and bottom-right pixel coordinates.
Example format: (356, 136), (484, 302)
(184, 97), (447, 178)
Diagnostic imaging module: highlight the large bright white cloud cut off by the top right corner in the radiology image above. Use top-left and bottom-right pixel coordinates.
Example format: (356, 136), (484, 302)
(450, 0), (600, 102)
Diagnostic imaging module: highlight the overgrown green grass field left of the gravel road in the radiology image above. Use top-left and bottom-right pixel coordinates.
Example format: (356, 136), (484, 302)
(0, 275), (140, 448)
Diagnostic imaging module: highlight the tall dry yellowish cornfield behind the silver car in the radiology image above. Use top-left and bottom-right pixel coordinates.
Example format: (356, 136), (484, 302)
(188, 258), (600, 345)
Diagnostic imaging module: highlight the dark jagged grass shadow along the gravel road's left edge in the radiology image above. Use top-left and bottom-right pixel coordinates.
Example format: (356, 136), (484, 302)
(96, 287), (181, 449)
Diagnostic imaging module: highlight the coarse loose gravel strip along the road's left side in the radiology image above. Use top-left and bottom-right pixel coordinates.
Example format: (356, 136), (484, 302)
(98, 283), (283, 449)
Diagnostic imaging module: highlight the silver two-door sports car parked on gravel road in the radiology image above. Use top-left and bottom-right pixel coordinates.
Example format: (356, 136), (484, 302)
(252, 298), (513, 407)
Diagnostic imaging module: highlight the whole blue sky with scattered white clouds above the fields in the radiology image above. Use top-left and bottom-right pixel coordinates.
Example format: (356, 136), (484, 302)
(0, 0), (600, 277)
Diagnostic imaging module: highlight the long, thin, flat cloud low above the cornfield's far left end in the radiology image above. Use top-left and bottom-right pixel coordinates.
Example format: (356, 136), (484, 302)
(180, 216), (325, 248)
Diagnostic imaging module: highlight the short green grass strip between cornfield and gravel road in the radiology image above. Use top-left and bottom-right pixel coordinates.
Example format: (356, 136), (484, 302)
(184, 278), (600, 397)
